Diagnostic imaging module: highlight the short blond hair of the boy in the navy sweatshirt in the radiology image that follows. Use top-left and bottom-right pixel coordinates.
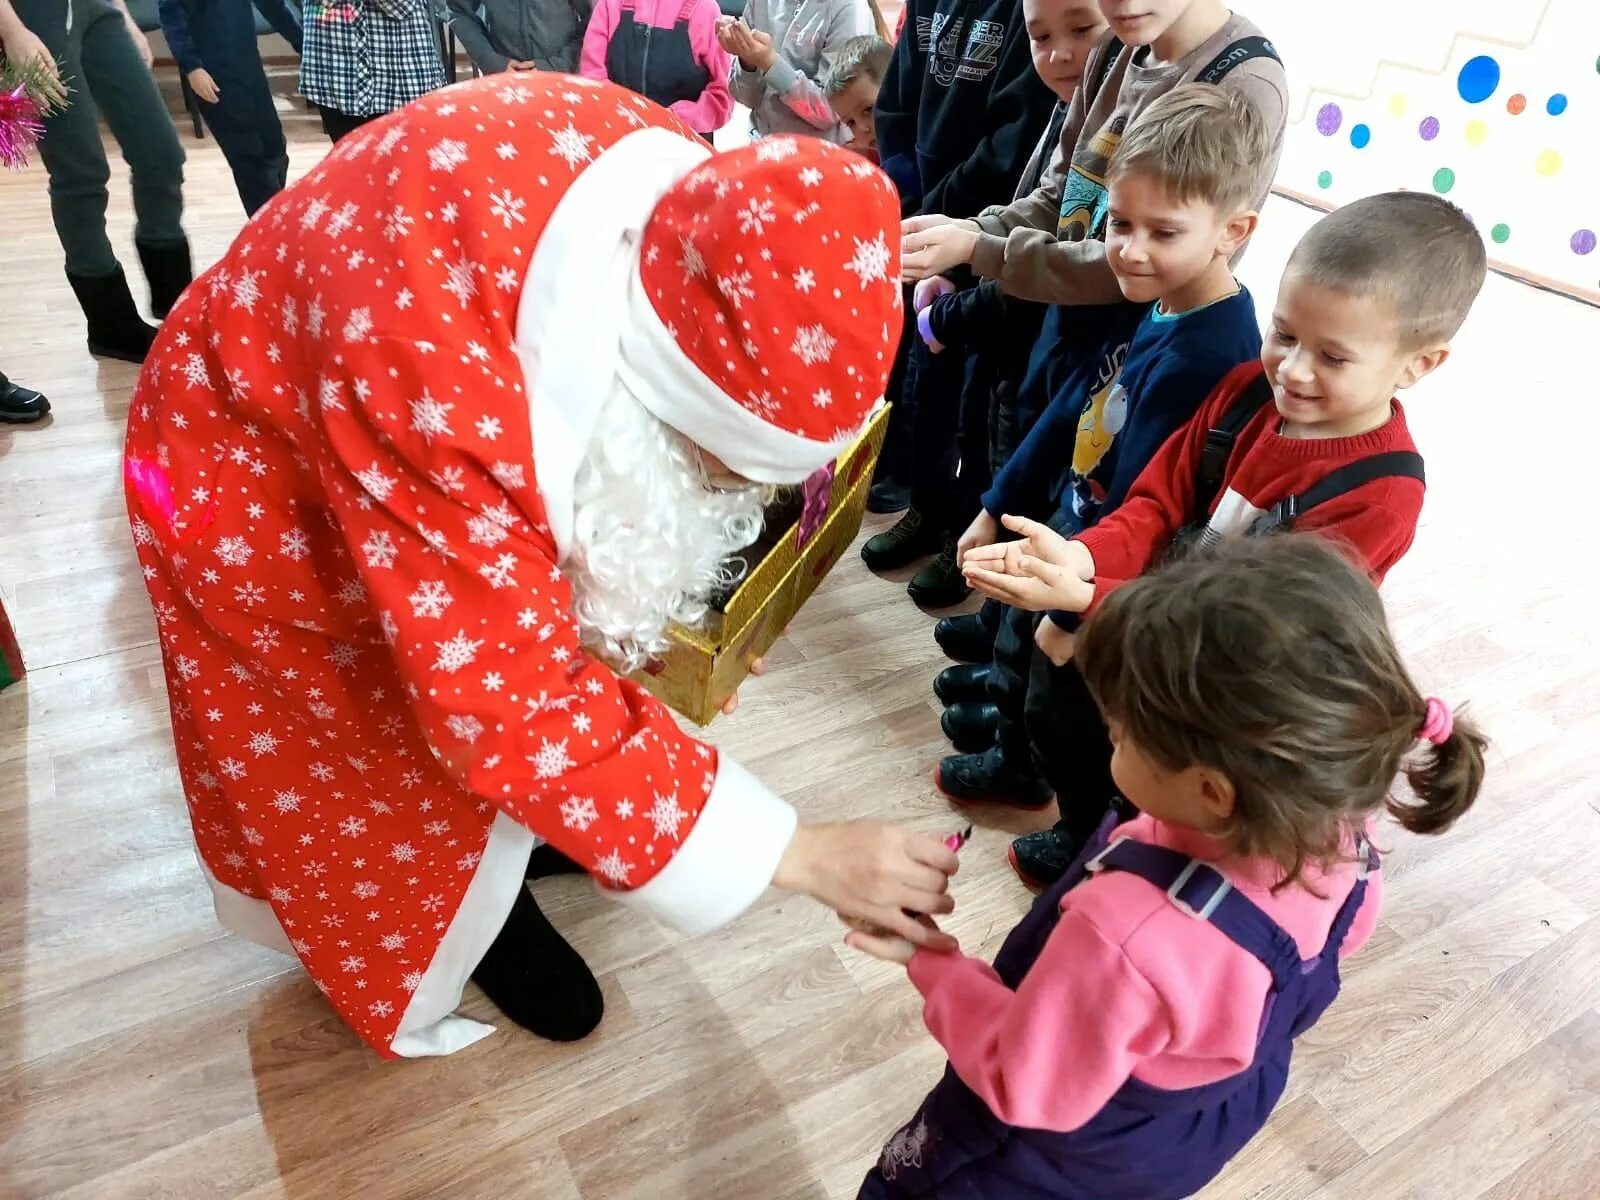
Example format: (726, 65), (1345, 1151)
(1106, 83), (1272, 214)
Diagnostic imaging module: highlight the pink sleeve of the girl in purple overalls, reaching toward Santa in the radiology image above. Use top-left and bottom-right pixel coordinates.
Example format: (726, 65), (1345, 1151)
(910, 910), (1171, 1133)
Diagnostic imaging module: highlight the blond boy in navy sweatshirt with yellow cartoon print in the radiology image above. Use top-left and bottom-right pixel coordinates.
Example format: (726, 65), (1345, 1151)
(936, 83), (1270, 880)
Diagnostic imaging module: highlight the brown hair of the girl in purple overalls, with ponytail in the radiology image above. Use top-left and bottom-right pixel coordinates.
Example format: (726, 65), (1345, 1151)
(1075, 534), (1488, 886)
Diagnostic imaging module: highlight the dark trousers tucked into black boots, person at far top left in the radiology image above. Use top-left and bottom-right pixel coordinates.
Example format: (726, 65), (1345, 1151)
(13, 0), (184, 278)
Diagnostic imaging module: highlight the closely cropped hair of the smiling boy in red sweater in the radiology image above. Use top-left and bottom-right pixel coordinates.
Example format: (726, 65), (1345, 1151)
(1288, 192), (1488, 349)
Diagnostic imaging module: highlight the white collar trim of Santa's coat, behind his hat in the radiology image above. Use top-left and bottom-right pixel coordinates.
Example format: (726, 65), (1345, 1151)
(515, 130), (710, 560)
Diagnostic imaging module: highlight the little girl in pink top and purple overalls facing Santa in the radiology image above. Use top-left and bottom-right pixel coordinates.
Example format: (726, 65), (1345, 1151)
(845, 533), (1485, 1200)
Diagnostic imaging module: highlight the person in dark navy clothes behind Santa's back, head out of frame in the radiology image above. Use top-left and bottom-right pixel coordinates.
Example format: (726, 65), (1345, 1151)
(155, 0), (301, 214)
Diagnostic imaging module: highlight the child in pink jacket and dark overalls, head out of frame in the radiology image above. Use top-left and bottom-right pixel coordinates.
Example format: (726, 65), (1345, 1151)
(578, 0), (733, 141)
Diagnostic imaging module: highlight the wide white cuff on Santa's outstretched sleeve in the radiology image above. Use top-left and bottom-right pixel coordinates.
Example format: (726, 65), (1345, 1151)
(606, 754), (798, 933)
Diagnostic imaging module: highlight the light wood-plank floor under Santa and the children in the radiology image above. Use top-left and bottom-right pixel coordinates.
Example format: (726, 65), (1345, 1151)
(0, 96), (1600, 1200)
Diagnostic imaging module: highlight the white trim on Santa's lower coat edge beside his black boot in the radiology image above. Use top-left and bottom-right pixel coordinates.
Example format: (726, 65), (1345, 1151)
(389, 813), (533, 1058)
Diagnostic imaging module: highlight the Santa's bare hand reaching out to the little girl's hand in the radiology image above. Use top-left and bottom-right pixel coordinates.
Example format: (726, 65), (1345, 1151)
(773, 821), (960, 950)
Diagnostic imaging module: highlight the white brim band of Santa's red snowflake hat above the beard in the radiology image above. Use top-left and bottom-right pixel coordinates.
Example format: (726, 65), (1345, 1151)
(617, 281), (861, 483)
